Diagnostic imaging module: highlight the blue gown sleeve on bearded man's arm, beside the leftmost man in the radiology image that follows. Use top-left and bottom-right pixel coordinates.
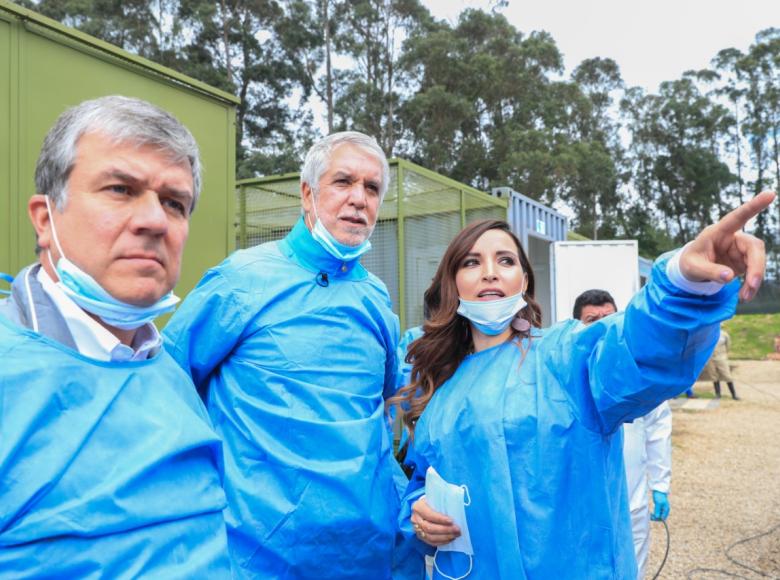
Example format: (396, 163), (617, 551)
(163, 268), (263, 395)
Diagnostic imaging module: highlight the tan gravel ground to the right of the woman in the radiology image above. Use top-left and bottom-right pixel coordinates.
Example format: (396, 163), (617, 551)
(647, 361), (780, 580)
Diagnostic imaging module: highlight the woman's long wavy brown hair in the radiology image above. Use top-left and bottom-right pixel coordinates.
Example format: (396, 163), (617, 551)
(388, 220), (542, 440)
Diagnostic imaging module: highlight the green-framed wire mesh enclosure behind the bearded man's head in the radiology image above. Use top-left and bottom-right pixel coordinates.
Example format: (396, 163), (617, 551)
(236, 160), (507, 328)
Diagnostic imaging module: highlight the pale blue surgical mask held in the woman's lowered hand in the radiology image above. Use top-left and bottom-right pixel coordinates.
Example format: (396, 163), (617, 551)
(425, 467), (474, 580)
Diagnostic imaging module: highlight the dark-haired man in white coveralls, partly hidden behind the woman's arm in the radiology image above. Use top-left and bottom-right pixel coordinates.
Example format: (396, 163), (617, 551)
(573, 290), (672, 580)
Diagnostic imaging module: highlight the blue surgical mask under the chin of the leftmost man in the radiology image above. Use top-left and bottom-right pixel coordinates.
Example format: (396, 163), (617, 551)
(45, 195), (179, 330)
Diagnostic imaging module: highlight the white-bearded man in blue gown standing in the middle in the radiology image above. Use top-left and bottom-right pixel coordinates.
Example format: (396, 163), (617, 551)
(164, 132), (406, 580)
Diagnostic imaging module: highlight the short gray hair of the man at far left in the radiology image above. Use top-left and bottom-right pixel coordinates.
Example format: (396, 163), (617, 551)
(35, 95), (201, 210)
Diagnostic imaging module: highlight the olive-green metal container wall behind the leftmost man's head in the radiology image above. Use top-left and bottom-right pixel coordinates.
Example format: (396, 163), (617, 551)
(0, 0), (239, 296)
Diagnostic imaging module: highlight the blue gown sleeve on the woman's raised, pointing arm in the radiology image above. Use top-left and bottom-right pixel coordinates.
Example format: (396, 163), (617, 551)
(541, 253), (740, 434)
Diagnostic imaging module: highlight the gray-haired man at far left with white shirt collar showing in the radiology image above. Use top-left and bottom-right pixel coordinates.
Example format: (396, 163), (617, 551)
(0, 96), (230, 578)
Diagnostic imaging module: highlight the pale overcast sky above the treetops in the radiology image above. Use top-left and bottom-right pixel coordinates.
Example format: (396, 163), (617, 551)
(422, 0), (780, 92)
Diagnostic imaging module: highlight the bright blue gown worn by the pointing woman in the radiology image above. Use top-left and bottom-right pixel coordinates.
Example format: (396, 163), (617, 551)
(401, 254), (739, 580)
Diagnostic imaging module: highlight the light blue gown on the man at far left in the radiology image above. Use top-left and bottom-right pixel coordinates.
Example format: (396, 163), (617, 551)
(0, 316), (230, 578)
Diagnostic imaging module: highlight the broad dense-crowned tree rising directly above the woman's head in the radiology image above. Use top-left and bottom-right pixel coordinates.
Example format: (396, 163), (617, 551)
(401, 10), (562, 193)
